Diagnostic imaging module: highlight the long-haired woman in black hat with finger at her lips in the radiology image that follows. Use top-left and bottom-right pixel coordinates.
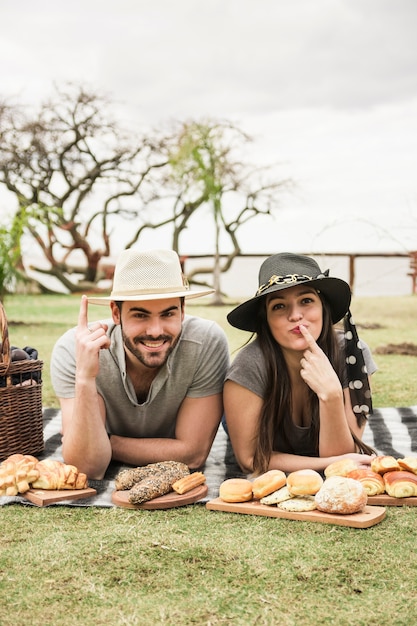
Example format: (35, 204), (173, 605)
(224, 253), (376, 474)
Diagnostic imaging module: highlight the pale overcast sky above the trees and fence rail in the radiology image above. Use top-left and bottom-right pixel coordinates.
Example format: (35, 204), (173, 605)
(0, 0), (417, 252)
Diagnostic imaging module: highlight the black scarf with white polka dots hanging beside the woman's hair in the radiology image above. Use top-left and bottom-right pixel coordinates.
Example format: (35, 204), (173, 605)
(343, 311), (372, 426)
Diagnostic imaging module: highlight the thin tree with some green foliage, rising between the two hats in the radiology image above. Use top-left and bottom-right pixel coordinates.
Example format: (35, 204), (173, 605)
(162, 120), (291, 304)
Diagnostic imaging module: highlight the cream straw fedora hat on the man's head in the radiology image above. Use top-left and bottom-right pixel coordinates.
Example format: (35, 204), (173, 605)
(88, 248), (214, 304)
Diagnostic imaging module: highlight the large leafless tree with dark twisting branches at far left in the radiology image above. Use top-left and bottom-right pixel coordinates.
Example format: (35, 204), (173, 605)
(0, 85), (166, 292)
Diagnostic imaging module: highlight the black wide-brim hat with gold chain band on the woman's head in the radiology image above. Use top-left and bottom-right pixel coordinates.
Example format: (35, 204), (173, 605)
(227, 252), (352, 332)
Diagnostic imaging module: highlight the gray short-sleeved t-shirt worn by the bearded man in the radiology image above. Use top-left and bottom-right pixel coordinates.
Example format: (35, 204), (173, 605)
(51, 315), (230, 437)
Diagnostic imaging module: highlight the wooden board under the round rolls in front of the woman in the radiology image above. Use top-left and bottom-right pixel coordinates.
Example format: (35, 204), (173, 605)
(206, 498), (386, 528)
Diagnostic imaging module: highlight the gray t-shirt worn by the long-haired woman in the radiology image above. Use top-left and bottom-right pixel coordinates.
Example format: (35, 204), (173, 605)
(226, 332), (377, 456)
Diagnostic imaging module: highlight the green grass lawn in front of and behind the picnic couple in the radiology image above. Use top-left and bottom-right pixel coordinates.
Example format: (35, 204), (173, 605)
(0, 296), (417, 626)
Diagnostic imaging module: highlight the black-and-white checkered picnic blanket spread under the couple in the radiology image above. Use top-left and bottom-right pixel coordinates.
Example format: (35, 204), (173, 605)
(0, 406), (417, 507)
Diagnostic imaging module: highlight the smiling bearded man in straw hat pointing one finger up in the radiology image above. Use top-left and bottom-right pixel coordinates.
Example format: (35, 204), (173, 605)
(51, 249), (229, 479)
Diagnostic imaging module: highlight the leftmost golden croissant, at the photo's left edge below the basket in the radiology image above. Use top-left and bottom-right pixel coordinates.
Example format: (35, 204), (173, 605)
(0, 454), (39, 496)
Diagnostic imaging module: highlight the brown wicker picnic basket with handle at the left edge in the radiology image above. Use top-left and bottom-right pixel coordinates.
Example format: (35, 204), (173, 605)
(0, 302), (44, 461)
